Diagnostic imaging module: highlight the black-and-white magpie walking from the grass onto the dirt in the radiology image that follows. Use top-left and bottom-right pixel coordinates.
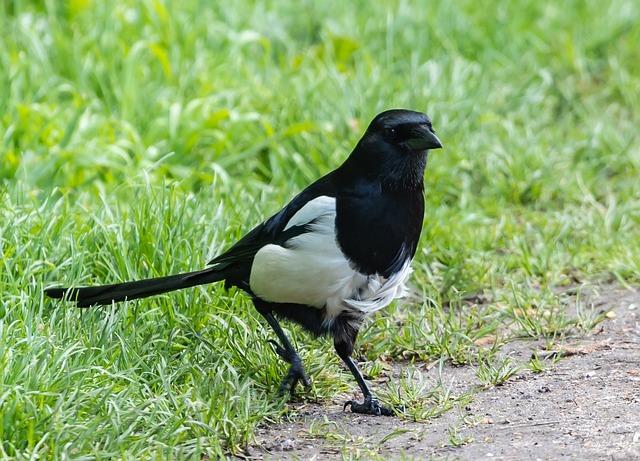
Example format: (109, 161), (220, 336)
(45, 109), (443, 416)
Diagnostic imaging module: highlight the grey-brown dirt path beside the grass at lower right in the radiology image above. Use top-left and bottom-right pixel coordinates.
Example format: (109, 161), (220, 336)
(248, 288), (640, 460)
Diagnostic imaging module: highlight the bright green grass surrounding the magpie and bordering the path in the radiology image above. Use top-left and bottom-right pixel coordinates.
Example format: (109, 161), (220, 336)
(0, 0), (640, 460)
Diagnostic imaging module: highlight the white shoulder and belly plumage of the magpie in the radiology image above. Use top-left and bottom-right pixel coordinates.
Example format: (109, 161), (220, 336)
(249, 196), (411, 322)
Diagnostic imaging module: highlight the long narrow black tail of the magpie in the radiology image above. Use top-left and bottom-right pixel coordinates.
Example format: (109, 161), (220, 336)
(44, 266), (227, 307)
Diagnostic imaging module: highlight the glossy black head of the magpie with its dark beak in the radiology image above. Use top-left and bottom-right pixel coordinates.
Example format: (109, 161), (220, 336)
(345, 109), (442, 188)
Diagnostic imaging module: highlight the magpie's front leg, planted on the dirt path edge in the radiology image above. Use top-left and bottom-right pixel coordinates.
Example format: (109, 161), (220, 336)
(333, 323), (394, 416)
